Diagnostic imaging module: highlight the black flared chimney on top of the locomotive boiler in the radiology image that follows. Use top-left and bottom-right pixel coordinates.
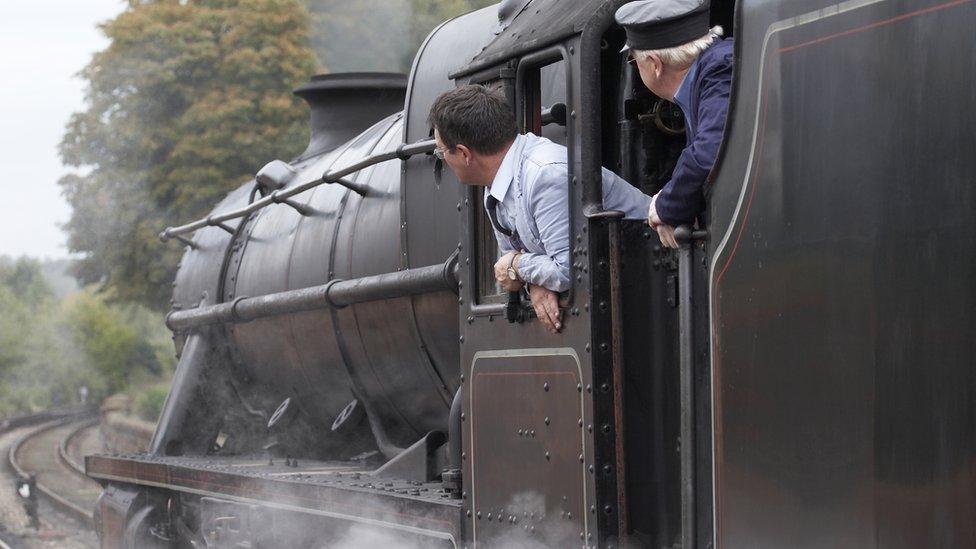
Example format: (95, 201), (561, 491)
(294, 72), (407, 158)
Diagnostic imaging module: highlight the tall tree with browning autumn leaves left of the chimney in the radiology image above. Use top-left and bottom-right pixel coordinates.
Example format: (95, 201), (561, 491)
(60, 0), (315, 309)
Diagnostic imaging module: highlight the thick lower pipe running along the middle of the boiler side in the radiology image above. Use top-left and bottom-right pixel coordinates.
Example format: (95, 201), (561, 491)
(166, 252), (457, 331)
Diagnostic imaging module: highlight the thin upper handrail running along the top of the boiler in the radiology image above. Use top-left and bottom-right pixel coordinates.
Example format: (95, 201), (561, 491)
(159, 139), (437, 241)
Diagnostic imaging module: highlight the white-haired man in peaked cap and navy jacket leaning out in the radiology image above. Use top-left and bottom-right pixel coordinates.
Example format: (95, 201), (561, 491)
(616, 0), (733, 248)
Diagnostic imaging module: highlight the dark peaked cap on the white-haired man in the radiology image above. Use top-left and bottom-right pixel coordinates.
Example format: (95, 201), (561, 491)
(614, 0), (709, 51)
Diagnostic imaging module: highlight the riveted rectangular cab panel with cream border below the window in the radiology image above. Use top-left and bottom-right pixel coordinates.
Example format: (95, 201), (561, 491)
(465, 349), (589, 546)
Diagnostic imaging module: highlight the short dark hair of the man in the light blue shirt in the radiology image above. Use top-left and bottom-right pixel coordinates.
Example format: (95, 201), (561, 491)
(427, 84), (518, 154)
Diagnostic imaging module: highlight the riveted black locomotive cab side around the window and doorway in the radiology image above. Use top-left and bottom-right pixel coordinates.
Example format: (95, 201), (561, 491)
(453, 2), (733, 547)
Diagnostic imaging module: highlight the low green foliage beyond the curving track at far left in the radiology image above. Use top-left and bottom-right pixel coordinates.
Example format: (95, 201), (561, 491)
(0, 258), (173, 416)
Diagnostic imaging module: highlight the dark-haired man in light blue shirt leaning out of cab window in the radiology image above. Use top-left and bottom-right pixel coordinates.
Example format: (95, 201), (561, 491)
(429, 85), (651, 333)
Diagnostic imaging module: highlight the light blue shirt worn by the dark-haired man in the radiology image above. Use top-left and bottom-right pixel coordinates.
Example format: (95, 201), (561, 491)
(485, 133), (651, 292)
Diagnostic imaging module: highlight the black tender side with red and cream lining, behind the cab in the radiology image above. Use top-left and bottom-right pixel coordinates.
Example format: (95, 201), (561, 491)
(708, 0), (976, 547)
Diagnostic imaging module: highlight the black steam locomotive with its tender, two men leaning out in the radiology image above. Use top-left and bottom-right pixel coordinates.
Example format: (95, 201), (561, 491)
(87, 0), (976, 548)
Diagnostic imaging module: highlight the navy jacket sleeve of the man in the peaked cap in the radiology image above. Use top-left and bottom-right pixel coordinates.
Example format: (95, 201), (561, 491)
(655, 55), (732, 226)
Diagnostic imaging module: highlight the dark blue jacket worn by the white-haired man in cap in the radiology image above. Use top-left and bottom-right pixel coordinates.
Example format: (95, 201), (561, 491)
(655, 38), (732, 226)
